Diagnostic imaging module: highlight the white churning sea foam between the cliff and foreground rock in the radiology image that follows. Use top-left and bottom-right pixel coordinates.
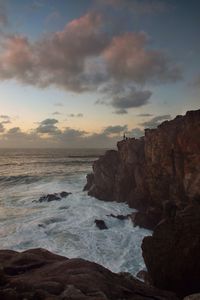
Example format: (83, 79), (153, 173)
(0, 149), (150, 275)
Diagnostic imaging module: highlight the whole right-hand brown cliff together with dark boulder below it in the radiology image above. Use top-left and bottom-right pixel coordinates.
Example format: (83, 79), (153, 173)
(85, 110), (200, 299)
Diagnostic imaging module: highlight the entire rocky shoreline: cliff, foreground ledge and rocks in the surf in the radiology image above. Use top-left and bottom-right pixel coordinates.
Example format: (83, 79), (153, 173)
(0, 110), (200, 300)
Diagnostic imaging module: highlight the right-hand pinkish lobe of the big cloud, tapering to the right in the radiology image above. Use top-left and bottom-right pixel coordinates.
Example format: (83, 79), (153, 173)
(104, 33), (181, 84)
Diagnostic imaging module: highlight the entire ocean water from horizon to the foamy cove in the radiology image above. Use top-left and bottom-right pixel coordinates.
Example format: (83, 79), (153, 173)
(0, 149), (150, 275)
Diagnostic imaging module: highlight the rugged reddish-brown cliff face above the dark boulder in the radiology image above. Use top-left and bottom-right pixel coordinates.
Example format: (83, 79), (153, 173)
(87, 110), (200, 221)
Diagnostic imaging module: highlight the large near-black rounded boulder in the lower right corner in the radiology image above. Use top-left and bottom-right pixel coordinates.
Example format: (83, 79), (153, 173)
(142, 204), (200, 296)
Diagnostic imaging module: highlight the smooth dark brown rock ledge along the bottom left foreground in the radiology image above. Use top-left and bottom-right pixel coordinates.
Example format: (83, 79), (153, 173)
(0, 249), (177, 300)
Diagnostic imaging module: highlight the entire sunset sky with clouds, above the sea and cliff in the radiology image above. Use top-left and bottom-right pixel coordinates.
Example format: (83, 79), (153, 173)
(0, 0), (200, 148)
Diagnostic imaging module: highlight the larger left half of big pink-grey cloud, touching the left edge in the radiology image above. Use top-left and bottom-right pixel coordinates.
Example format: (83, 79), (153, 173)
(0, 13), (108, 92)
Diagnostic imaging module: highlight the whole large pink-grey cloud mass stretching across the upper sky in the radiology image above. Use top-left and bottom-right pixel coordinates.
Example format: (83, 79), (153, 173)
(0, 12), (181, 93)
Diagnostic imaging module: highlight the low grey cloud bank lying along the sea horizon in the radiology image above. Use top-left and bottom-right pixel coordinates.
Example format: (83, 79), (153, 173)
(0, 119), (145, 148)
